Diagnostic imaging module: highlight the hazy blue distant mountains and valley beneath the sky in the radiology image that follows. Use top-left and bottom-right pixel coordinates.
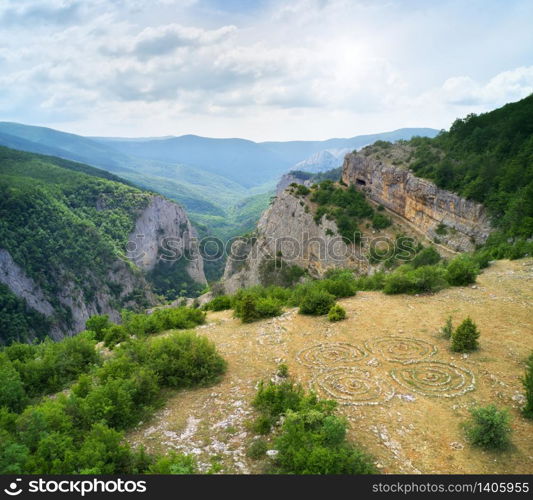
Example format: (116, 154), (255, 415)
(0, 122), (438, 238)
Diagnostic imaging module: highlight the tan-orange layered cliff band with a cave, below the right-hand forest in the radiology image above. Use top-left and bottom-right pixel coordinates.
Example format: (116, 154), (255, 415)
(342, 150), (491, 252)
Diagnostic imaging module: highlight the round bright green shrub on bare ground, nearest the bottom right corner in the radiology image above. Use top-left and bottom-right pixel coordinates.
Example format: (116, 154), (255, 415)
(465, 405), (511, 450)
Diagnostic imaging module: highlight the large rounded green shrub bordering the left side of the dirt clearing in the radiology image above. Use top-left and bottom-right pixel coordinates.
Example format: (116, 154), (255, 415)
(147, 332), (226, 389)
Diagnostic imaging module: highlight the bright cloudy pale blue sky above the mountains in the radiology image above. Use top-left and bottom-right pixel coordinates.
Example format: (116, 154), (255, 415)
(0, 0), (533, 141)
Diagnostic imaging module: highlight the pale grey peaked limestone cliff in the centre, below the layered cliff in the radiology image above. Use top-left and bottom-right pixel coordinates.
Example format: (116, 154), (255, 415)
(223, 190), (366, 294)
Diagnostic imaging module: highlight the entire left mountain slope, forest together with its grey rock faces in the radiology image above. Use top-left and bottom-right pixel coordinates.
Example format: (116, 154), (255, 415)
(0, 147), (205, 342)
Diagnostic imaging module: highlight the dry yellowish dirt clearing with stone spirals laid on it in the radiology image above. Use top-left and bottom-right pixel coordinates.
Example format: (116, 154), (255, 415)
(128, 259), (533, 474)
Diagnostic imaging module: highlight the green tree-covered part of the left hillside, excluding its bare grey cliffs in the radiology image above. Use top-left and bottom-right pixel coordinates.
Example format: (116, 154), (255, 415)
(0, 147), (156, 342)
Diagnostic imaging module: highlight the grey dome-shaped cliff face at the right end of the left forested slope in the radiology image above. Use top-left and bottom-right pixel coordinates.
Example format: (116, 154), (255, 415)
(127, 196), (207, 283)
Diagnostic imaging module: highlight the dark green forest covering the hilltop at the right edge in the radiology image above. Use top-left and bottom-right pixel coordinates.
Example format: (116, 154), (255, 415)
(407, 95), (533, 254)
